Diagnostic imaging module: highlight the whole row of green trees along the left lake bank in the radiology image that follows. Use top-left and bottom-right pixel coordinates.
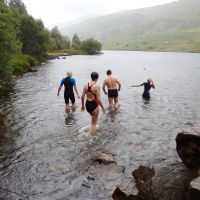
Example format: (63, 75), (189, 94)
(0, 0), (101, 88)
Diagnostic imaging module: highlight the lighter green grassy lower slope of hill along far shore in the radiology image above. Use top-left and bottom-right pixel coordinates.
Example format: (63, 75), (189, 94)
(104, 29), (200, 52)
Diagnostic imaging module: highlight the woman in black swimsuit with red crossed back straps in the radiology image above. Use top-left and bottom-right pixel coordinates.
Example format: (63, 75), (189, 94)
(81, 72), (105, 135)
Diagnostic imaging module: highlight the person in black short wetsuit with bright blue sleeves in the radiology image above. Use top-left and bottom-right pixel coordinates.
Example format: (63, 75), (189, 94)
(57, 72), (80, 112)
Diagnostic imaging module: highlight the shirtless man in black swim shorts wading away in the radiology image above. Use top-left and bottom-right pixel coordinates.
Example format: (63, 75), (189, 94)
(103, 70), (121, 109)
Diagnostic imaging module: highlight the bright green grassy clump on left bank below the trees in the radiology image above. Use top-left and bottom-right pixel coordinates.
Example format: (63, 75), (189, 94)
(11, 55), (37, 75)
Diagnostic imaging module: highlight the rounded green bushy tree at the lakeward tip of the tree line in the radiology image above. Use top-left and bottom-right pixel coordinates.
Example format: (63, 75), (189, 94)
(81, 38), (102, 55)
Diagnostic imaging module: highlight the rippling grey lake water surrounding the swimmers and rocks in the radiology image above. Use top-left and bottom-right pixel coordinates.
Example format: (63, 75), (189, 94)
(0, 51), (200, 200)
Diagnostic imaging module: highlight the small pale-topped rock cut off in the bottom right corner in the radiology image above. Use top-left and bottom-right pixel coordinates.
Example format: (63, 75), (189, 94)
(189, 177), (200, 200)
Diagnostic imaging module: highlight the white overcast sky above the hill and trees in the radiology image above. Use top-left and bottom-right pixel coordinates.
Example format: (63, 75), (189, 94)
(23, 0), (176, 27)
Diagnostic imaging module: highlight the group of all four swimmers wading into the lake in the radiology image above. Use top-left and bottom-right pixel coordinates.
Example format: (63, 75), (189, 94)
(57, 70), (155, 135)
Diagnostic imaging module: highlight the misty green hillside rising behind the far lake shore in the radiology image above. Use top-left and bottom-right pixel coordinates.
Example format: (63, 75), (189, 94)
(61, 0), (200, 52)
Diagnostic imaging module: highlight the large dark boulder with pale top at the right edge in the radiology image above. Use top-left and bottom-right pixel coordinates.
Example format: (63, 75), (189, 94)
(176, 126), (200, 169)
